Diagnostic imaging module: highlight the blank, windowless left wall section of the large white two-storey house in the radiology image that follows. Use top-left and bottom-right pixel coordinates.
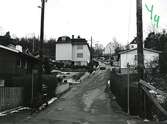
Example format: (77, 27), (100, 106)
(55, 43), (72, 60)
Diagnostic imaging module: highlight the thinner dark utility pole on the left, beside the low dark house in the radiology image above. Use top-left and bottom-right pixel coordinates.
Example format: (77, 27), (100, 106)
(38, 0), (47, 92)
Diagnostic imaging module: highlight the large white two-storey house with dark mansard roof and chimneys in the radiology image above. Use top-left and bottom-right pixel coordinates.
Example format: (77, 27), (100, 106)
(55, 36), (90, 65)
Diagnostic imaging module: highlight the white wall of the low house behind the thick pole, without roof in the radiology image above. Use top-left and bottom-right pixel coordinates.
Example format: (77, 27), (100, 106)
(121, 50), (159, 68)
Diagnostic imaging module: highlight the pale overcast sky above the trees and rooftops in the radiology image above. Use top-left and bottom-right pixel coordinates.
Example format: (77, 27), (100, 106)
(0, 0), (167, 46)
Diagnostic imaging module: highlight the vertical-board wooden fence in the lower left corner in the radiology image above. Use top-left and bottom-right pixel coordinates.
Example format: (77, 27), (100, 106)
(0, 87), (23, 111)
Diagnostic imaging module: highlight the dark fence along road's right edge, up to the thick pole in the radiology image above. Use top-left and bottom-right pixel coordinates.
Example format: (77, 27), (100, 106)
(110, 72), (139, 115)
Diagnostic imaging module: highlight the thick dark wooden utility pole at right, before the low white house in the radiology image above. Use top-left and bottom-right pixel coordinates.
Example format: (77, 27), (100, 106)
(136, 0), (145, 116)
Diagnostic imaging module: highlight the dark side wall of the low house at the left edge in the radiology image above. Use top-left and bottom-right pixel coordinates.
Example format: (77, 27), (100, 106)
(0, 49), (38, 79)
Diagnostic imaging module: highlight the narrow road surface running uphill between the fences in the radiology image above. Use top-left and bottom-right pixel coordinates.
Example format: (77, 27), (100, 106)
(0, 70), (149, 124)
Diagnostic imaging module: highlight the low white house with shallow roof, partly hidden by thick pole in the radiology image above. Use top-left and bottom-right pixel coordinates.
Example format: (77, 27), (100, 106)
(120, 48), (160, 68)
